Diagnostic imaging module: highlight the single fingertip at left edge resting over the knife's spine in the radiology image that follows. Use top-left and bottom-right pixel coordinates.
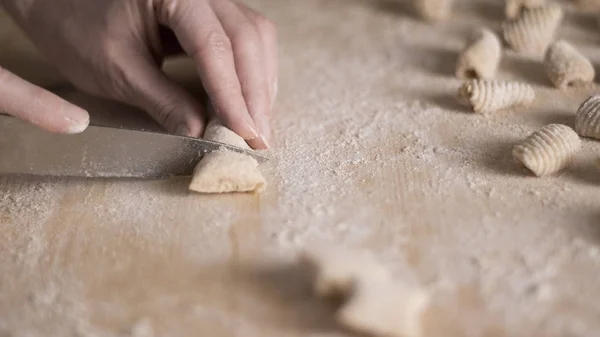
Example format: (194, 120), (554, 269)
(0, 67), (90, 133)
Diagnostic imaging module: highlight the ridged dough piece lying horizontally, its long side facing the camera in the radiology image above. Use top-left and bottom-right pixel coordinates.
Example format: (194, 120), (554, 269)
(458, 80), (535, 114)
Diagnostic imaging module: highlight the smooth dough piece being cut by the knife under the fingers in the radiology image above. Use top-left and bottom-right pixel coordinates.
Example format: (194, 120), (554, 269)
(189, 120), (266, 193)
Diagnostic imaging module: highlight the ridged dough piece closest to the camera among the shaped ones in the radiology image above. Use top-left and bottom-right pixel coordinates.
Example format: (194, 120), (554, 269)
(513, 124), (581, 177)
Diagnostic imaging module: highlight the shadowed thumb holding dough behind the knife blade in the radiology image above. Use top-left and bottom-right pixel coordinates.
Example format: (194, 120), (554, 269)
(116, 50), (205, 137)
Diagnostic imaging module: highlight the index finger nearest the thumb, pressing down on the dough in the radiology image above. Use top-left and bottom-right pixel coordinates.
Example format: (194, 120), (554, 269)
(157, 0), (259, 147)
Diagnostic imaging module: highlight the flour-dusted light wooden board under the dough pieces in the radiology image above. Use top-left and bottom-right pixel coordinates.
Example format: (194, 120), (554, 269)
(0, 0), (600, 336)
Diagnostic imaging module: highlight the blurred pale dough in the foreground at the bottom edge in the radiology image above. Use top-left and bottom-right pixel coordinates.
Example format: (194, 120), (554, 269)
(301, 248), (430, 337)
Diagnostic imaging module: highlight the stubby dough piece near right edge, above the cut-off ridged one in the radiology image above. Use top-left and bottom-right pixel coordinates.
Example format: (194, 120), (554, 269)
(544, 40), (596, 89)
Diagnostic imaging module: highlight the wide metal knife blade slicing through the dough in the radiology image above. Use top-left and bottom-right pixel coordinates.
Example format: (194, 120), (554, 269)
(0, 114), (268, 179)
